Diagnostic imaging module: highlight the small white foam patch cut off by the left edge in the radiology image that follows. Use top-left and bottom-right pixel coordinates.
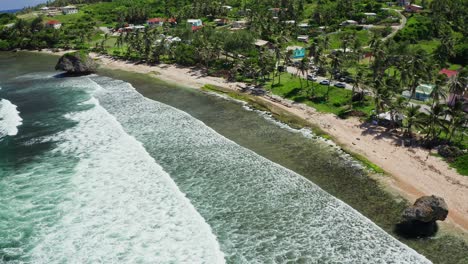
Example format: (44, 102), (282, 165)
(0, 99), (23, 139)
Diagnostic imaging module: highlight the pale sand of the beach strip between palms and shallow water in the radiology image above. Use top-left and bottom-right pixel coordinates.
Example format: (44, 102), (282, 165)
(91, 54), (468, 232)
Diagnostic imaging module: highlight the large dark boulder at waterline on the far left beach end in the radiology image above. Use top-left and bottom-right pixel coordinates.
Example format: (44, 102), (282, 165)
(55, 52), (97, 75)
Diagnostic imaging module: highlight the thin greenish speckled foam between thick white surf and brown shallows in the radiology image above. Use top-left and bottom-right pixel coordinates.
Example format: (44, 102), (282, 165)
(88, 78), (430, 264)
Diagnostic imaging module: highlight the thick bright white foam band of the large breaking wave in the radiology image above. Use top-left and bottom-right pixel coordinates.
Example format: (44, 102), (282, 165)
(31, 95), (225, 264)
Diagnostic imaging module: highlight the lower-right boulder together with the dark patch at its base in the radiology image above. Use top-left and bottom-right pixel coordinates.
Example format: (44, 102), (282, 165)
(395, 195), (448, 238)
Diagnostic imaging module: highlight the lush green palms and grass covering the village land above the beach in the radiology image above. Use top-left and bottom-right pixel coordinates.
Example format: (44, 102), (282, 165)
(0, 0), (468, 173)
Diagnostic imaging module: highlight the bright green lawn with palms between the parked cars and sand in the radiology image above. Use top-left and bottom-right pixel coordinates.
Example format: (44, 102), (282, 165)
(265, 73), (374, 116)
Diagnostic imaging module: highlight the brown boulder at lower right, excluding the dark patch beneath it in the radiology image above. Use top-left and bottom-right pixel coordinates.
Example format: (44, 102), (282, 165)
(403, 195), (448, 223)
